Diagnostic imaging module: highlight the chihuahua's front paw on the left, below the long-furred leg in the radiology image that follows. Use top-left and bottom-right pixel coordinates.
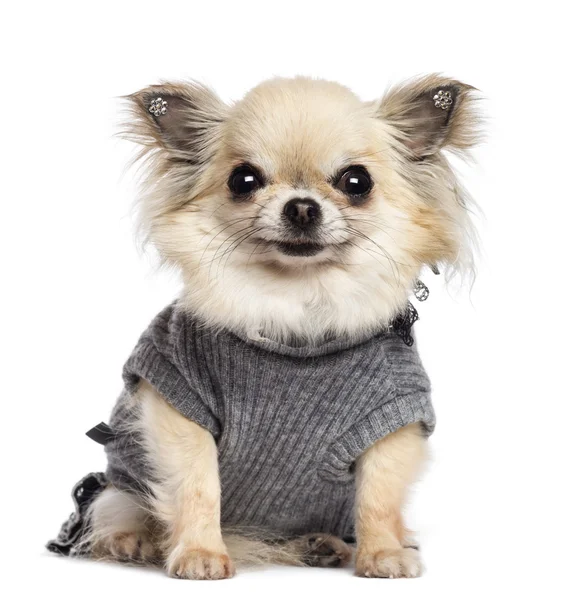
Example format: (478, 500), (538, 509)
(168, 548), (234, 579)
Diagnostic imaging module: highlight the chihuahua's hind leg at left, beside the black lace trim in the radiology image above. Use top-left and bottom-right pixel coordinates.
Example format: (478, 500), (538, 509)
(88, 486), (159, 563)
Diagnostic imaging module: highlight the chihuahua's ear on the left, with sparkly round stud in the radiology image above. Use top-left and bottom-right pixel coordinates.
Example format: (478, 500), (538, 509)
(122, 82), (227, 164)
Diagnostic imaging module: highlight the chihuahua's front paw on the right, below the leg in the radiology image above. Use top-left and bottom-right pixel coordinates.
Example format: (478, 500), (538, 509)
(356, 548), (422, 579)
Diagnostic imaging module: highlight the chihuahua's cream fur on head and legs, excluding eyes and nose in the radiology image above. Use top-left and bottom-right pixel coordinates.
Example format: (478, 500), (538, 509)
(86, 75), (479, 579)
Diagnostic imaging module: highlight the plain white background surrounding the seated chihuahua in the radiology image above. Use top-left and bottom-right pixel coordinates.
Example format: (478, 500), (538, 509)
(0, 0), (582, 599)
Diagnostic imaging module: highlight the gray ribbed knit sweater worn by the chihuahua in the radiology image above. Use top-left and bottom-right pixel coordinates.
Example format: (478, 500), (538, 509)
(106, 304), (435, 537)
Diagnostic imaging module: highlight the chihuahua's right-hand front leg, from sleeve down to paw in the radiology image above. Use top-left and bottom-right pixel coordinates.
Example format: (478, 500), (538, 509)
(356, 424), (426, 577)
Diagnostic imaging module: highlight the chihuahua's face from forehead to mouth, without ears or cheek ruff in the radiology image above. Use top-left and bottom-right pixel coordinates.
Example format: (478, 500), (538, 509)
(217, 80), (390, 270)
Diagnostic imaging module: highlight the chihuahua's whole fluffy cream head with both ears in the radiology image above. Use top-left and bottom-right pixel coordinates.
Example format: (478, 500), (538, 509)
(128, 76), (476, 338)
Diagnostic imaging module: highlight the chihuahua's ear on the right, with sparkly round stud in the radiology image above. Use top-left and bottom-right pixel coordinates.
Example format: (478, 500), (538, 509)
(379, 75), (479, 159)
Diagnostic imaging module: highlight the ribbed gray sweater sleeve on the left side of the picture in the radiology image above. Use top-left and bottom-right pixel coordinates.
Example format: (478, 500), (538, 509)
(123, 304), (221, 438)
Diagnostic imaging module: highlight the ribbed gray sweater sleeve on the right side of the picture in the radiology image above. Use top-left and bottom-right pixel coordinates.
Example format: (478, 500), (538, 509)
(319, 340), (436, 483)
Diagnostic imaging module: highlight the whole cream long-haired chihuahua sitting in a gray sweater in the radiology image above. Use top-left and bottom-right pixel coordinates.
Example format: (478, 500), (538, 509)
(49, 75), (477, 579)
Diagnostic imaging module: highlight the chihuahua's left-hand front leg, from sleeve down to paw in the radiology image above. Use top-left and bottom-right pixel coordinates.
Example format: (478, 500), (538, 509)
(138, 382), (234, 579)
